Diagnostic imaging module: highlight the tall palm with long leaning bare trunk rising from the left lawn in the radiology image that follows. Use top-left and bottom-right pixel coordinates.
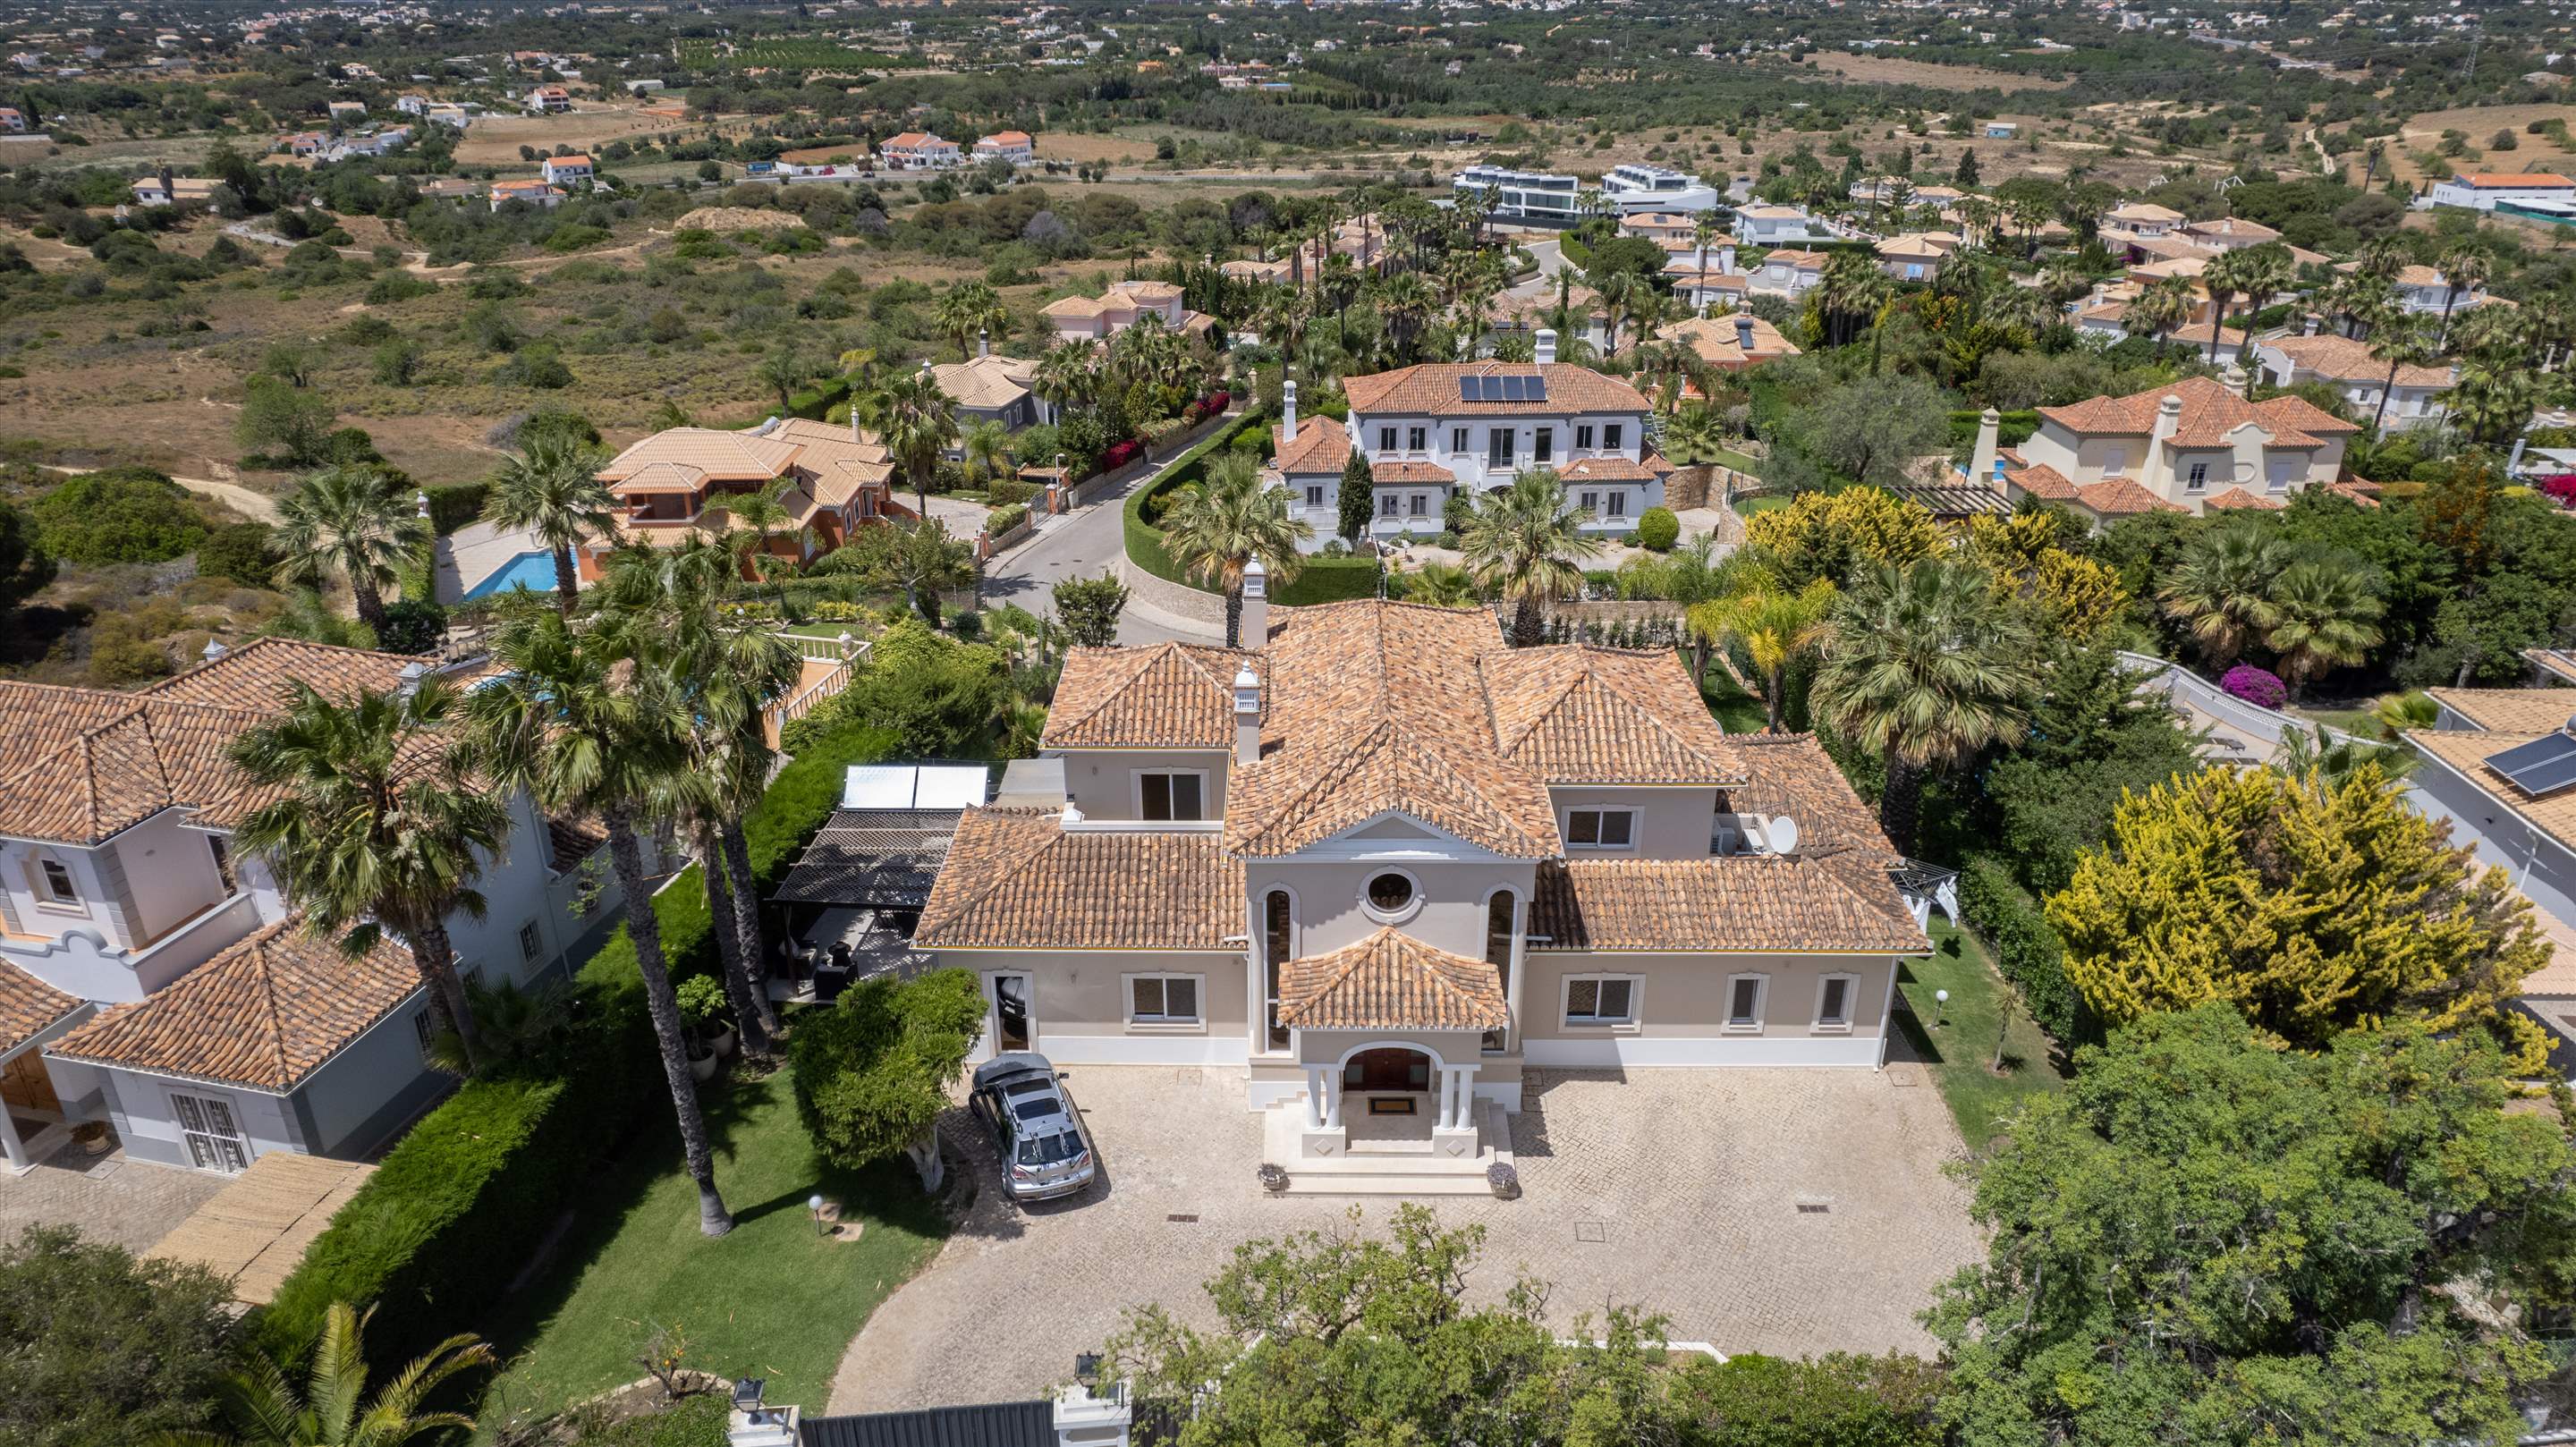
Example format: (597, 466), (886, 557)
(466, 613), (734, 1236)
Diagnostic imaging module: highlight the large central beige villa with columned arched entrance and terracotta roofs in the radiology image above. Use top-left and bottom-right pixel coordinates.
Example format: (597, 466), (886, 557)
(912, 595), (1929, 1192)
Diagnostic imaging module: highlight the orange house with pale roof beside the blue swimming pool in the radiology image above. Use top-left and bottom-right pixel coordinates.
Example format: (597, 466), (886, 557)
(580, 417), (894, 582)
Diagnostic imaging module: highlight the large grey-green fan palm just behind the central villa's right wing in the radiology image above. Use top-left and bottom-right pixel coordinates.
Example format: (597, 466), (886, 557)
(1814, 556), (2040, 850)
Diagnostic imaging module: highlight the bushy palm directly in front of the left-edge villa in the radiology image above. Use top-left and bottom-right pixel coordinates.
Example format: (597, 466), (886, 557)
(232, 674), (510, 1063)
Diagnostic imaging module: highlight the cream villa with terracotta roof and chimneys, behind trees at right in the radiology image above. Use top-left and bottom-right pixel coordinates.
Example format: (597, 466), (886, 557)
(1968, 368), (2360, 522)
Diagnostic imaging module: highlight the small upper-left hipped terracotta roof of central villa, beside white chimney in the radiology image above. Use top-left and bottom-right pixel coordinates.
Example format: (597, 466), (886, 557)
(1038, 644), (1262, 749)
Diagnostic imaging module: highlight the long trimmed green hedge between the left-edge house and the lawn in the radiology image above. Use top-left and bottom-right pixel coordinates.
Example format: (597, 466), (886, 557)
(252, 729), (896, 1362)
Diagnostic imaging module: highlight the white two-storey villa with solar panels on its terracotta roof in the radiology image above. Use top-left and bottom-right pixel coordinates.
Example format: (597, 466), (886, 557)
(1267, 340), (1672, 551)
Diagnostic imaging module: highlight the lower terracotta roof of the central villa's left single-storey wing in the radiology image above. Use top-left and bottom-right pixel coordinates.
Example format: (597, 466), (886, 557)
(912, 808), (1244, 950)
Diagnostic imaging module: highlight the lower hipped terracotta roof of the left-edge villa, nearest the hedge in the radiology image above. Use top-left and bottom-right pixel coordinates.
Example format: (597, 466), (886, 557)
(47, 914), (419, 1092)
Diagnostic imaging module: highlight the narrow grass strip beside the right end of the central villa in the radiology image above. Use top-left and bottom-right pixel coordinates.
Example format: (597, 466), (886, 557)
(1896, 914), (2066, 1151)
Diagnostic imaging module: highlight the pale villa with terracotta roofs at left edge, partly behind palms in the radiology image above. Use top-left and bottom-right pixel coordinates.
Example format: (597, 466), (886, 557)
(0, 639), (641, 1174)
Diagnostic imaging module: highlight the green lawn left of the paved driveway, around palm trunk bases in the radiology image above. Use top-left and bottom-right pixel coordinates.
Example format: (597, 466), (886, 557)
(484, 1071), (948, 1426)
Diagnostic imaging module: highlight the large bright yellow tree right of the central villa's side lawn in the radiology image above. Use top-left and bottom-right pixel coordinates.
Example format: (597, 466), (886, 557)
(2048, 762), (2547, 1069)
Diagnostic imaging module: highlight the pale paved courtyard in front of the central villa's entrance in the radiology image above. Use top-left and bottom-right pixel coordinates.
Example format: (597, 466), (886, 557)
(832, 1066), (1979, 1411)
